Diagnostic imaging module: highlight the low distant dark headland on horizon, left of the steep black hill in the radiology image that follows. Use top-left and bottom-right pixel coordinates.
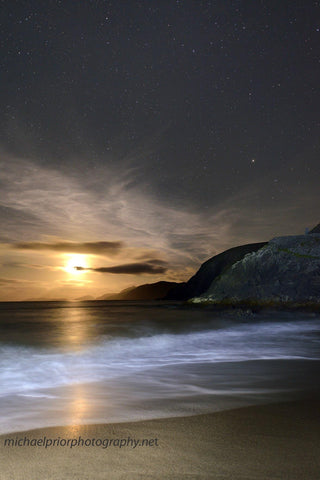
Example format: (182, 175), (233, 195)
(97, 281), (179, 300)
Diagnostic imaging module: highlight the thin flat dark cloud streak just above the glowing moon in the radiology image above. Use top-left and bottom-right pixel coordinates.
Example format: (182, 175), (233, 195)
(12, 242), (123, 255)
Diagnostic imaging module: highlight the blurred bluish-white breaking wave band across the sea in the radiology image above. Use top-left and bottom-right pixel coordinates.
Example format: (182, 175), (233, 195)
(0, 319), (320, 396)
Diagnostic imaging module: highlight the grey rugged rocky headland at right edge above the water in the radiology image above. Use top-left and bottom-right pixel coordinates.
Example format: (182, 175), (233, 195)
(192, 232), (320, 304)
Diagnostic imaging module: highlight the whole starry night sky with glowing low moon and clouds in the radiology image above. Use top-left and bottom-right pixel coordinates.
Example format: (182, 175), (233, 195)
(0, 0), (320, 300)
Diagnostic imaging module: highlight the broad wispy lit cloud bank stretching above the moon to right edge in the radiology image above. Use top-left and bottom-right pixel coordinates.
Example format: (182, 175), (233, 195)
(0, 148), (318, 271)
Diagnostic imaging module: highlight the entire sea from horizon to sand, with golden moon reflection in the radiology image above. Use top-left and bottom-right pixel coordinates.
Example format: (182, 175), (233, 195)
(0, 302), (320, 433)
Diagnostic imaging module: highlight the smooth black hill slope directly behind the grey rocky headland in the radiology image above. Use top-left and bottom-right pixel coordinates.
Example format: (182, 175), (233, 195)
(165, 242), (267, 300)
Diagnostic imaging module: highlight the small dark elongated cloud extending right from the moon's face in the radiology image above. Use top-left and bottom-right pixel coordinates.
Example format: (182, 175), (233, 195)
(74, 260), (167, 275)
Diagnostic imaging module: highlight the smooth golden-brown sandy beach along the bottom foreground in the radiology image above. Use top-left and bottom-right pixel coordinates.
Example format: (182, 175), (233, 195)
(0, 400), (320, 480)
